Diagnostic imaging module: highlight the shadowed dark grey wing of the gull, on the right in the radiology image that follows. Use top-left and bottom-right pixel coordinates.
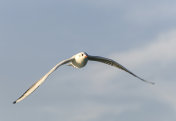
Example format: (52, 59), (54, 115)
(88, 55), (155, 84)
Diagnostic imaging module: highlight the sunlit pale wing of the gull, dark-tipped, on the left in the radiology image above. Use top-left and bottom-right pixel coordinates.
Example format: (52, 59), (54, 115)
(13, 58), (72, 104)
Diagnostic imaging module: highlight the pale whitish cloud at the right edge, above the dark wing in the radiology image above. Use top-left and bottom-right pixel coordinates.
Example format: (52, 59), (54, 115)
(110, 30), (176, 67)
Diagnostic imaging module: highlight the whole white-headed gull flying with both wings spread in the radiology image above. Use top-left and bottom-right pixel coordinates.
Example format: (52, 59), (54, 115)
(13, 52), (155, 104)
